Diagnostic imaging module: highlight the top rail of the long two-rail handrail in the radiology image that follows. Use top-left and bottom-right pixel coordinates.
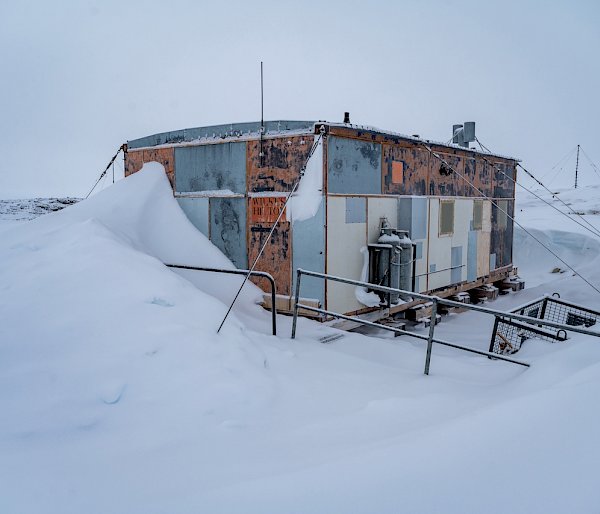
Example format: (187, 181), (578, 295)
(298, 269), (600, 337)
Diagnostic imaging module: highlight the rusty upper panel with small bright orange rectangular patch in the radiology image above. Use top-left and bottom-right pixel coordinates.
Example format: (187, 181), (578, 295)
(382, 144), (430, 195)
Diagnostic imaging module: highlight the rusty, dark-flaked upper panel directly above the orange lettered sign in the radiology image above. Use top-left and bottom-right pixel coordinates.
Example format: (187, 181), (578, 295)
(246, 135), (314, 193)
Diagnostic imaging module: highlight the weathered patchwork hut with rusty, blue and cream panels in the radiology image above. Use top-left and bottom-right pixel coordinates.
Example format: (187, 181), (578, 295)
(125, 121), (517, 313)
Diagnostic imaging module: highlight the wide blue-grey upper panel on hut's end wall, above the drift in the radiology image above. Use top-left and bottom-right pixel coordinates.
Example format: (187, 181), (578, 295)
(175, 142), (246, 194)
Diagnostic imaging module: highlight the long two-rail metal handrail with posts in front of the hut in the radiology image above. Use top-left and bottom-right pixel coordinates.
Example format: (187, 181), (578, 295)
(292, 268), (600, 375)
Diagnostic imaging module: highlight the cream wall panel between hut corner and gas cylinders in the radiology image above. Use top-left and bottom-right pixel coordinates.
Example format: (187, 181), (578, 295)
(327, 196), (367, 313)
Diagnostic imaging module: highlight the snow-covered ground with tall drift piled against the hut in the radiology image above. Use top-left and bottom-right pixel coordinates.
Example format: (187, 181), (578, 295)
(0, 165), (600, 514)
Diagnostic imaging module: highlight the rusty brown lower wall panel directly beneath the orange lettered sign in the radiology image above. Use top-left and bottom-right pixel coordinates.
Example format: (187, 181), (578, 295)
(248, 216), (292, 296)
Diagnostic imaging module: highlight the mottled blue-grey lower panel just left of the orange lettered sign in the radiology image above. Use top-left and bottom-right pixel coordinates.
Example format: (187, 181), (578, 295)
(210, 198), (248, 269)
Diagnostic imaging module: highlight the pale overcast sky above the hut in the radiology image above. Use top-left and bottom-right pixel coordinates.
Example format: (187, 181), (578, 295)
(0, 0), (600, 198)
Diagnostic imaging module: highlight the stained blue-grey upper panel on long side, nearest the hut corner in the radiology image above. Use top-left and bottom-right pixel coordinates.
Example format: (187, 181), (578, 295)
(327, 136), (382, 194)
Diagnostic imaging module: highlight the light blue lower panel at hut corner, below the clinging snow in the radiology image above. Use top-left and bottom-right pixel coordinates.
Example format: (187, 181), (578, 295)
(292, 200), (325, 305)
